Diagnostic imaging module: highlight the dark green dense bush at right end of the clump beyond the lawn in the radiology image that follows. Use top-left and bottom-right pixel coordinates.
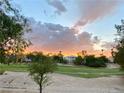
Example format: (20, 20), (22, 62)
(85, 55), (106, 67)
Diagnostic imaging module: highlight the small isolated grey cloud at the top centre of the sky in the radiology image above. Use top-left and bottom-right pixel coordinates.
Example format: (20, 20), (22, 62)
(47, 0), (67, 15)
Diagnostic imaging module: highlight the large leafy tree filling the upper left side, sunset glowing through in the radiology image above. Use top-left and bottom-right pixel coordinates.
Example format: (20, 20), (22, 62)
(0, 0), (30, 63)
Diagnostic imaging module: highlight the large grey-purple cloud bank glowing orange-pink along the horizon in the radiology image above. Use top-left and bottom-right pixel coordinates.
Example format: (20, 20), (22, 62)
(26, 19), (97, 54)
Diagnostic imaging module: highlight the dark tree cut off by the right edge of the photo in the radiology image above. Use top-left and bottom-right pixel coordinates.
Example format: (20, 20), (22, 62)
(114, 20), (124, 68)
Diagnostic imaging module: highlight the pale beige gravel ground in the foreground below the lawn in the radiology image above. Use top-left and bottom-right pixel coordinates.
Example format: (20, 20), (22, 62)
(0, 72), (124, 93)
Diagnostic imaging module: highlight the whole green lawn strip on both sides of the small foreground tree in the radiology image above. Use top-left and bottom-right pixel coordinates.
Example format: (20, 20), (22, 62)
(0, 64), (124, 78)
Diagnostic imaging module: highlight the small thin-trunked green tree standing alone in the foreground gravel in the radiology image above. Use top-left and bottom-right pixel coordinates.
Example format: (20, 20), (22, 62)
(29, 53), (56, 93)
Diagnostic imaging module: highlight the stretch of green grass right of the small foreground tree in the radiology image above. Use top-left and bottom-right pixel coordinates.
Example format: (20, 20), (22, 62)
(56, 66), (124, 78)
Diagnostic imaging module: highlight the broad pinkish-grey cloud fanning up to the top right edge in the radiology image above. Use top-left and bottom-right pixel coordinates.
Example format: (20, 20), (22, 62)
(74, 0), (118, 29)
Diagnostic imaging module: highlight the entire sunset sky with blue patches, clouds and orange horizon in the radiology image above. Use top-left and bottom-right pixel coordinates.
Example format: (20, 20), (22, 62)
(12, 0), (124, 56)
